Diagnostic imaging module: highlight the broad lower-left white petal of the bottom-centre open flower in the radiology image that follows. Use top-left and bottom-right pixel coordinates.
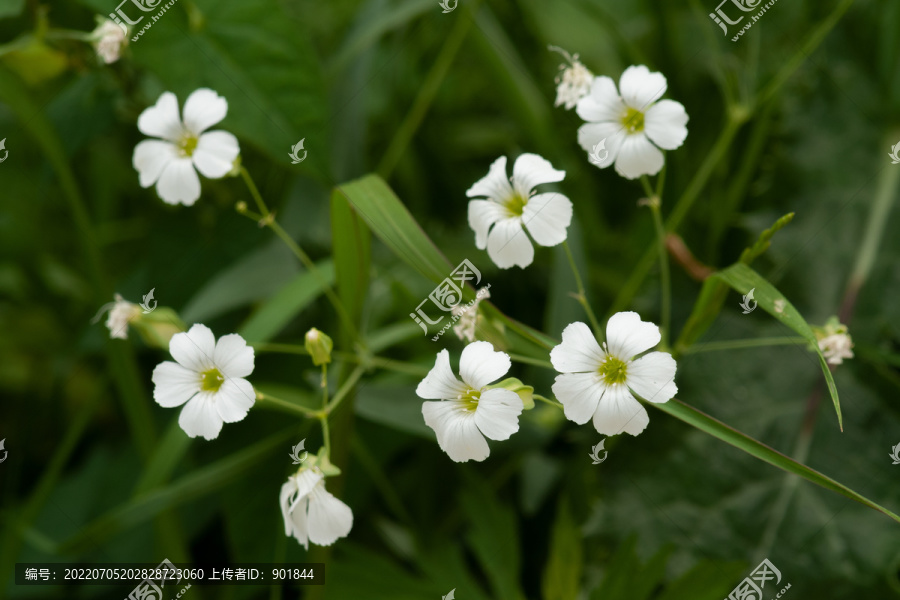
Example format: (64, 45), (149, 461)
(422, 400), (491, 462)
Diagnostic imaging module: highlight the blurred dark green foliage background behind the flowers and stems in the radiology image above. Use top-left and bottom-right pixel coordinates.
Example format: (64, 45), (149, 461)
(0, 0), (900, 600)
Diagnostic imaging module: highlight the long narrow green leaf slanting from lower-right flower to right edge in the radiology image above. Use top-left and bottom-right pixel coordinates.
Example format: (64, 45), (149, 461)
(651, 398), (900, 523)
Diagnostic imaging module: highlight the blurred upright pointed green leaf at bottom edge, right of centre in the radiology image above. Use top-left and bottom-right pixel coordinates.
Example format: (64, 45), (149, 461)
(541, 496), (583, 600)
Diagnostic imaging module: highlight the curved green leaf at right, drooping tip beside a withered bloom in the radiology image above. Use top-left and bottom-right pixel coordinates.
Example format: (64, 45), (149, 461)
(712, 263), (844, 431)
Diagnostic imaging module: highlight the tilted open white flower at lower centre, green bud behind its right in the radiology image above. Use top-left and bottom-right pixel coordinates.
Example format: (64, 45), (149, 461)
(416, 342), (523, 462)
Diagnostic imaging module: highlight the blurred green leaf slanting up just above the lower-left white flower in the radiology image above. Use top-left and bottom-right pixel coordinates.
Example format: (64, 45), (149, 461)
(238, 260), (334, 343)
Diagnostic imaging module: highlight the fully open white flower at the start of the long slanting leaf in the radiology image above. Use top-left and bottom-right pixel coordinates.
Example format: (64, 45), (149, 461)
(550, 312), (678, 435)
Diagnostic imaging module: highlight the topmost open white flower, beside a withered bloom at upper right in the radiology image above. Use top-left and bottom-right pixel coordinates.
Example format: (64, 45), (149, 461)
(575, 65), (688, 179)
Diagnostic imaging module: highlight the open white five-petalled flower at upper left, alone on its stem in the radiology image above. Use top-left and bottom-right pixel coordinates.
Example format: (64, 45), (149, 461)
(132, 88), (241, 206)
